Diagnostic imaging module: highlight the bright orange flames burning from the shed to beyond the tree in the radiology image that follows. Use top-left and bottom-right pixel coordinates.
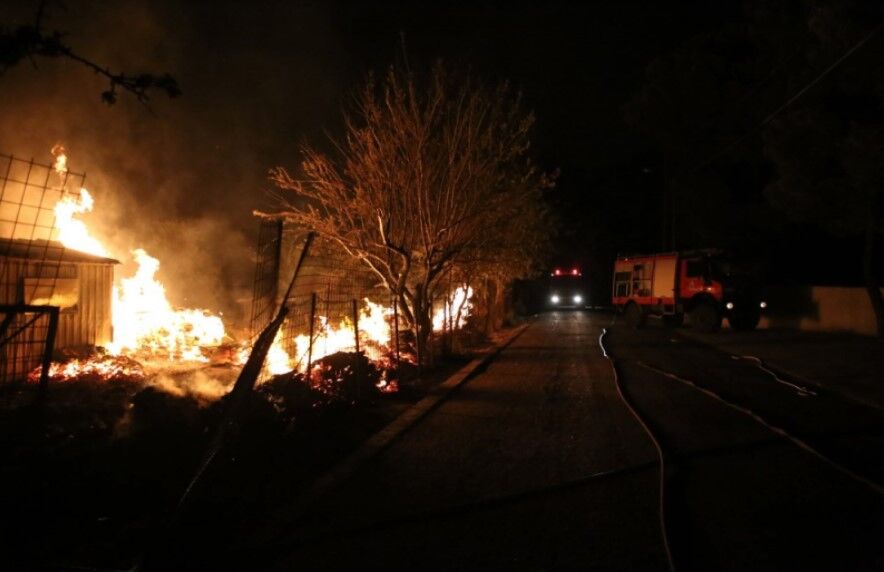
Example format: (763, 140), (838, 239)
(32, 146), (473, 396)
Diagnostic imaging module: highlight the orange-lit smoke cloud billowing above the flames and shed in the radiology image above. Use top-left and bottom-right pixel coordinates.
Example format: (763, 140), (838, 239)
(0, 0), (349, 327)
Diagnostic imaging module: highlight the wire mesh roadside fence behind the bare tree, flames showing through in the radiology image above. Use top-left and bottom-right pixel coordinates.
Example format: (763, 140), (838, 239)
(251, 221), (486, 382)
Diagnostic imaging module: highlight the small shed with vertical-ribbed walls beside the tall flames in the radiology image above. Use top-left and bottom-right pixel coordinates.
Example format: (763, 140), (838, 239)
(0, 239), (118, 380)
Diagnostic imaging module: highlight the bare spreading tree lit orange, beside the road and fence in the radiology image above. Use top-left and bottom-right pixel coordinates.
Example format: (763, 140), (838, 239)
(271, 63), (552, 362)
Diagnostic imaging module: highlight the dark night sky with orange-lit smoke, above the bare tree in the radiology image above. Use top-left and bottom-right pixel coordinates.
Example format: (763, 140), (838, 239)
(0, 0), (727, 319)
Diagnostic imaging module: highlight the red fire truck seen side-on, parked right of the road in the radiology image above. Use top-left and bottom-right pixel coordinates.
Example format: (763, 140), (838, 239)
(612, 249), (767, 332)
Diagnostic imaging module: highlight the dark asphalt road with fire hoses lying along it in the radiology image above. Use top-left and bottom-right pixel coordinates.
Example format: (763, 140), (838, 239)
(268, 312), (884, 571)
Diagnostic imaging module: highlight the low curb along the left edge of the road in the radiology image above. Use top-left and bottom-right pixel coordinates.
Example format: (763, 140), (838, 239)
(286, 323), (531, 519)
